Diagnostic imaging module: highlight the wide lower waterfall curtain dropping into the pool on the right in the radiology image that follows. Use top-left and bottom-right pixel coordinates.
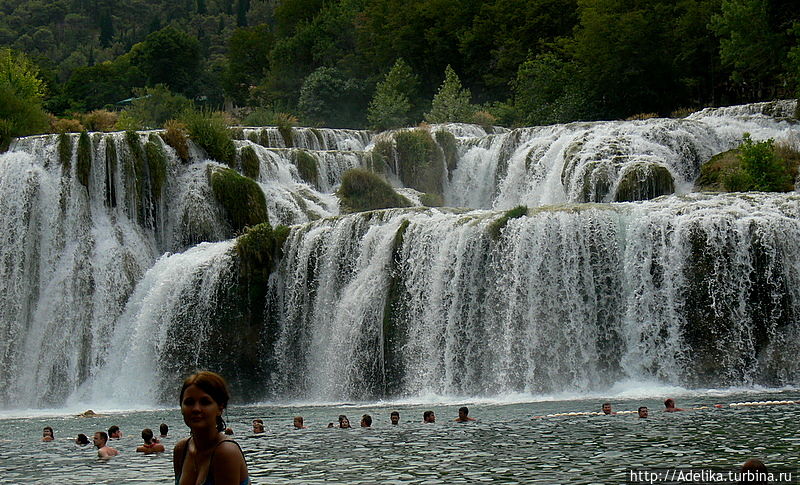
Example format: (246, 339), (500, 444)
(273, 194), (800, 400)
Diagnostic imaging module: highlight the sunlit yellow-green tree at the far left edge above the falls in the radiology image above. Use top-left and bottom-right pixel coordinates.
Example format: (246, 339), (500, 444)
(0, 49), (48, 151)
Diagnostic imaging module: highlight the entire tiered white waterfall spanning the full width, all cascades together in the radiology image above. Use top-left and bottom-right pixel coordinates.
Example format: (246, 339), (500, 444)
(0, 102), (800, 407)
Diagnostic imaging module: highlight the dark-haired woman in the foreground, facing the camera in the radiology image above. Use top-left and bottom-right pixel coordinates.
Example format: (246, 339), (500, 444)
(172, 371), (250, 485)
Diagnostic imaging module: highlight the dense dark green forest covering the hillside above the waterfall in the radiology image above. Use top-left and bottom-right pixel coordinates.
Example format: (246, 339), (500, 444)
(0, 0), (800, 140)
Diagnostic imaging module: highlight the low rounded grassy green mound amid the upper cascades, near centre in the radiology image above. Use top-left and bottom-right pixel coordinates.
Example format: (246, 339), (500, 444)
(336, 168), (412, 212)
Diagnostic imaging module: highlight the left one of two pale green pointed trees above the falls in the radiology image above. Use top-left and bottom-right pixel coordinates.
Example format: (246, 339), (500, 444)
(367, 58), (418, 130)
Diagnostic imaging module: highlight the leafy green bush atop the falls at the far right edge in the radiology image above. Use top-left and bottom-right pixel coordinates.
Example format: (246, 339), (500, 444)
(723, 133), (796, 192)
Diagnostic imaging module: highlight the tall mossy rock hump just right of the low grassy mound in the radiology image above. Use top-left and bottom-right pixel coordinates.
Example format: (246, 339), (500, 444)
(394, 128), (445, 195)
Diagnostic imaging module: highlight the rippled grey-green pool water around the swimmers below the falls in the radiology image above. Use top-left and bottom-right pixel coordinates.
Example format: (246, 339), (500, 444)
(0, 392), (800, 484)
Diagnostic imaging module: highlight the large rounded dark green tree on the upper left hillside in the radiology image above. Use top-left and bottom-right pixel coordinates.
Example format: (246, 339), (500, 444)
(130, 26), (201, 93)
